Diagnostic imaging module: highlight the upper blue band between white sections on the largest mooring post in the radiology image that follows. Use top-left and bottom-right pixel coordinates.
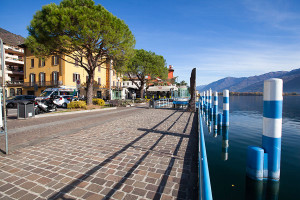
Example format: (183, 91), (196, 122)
(263, 101), (282, 119)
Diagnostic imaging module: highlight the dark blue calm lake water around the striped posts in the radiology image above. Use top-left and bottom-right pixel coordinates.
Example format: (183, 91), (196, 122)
(204, 96), (300, 200)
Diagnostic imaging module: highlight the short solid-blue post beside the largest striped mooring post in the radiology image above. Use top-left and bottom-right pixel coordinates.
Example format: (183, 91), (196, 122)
(246, 146), (264, 181)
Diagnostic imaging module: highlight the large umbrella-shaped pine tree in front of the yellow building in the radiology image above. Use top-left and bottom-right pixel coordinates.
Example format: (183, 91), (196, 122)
(25, 0), (135, 104)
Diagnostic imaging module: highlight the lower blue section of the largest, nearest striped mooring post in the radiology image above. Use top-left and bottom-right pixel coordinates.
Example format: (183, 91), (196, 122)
(262, 135), (281, 180)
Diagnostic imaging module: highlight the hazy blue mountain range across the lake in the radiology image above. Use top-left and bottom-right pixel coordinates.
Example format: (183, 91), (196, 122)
(196, 68), (300, 93)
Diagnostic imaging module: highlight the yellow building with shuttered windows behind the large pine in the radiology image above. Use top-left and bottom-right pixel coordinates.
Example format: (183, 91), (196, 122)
(23, 47), (122, 99)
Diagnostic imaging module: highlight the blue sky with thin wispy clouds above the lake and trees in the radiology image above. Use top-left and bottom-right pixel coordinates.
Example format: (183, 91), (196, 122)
(0, 0), (300, 85)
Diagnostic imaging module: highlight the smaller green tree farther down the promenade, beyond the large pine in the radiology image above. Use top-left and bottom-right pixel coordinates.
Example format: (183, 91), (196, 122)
(126, 49), (168, 97)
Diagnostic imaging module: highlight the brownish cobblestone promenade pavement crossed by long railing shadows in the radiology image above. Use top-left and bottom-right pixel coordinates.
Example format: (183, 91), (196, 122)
(0, 108), (197, 200)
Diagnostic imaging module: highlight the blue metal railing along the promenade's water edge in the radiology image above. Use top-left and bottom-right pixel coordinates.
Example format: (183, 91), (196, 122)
(198, 102), (213, 200)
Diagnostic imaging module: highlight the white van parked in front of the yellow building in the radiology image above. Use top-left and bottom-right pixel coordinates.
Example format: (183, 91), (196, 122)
(35, 88), (78, 101)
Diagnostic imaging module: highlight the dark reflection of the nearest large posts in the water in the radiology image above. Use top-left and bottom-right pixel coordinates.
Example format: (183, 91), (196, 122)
(245, 177), (280, 200)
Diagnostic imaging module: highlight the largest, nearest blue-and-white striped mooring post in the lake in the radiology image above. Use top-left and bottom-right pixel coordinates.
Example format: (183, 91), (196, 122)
(262, 78), (283, 180)
